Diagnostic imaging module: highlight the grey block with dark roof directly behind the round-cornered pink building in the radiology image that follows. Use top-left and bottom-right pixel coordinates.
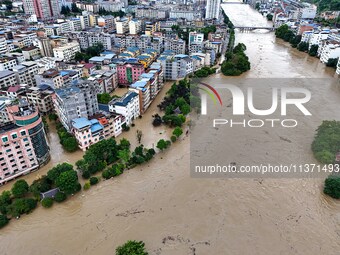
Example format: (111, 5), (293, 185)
(26, 85), (54, 115)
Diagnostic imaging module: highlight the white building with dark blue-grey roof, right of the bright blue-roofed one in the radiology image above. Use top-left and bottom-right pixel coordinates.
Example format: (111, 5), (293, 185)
(109, 91), (140, 125)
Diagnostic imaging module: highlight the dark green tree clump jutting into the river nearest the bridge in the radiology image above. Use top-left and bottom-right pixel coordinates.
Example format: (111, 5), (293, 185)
(221, 43), (250, 76)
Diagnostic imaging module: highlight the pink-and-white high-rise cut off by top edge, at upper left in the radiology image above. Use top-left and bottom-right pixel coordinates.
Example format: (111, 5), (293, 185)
(23, 0), (60, 20)
